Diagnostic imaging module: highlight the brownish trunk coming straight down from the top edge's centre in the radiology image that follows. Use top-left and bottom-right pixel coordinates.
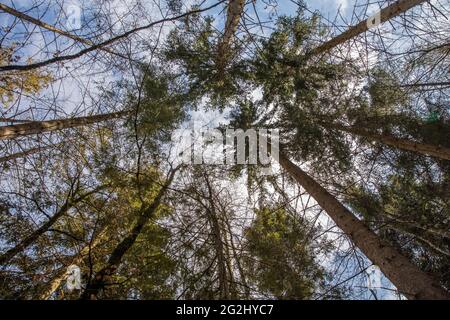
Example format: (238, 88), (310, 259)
(216, 0), (245, 71)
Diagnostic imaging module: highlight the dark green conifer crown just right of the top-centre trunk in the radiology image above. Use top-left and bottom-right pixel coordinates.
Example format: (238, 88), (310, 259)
(251, 12), (341, 104)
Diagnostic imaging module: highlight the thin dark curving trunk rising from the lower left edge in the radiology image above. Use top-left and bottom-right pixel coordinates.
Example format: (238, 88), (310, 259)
(0, 186), (105, 265)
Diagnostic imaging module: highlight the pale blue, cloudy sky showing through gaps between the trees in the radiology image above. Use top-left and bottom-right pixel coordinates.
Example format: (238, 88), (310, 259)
(0, 0), (434, 299)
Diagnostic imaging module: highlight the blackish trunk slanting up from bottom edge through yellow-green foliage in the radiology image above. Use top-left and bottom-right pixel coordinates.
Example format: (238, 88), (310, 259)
(81, 169), (177, 300)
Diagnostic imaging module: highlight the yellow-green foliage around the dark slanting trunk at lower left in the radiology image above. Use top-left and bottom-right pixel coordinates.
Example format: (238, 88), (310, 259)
(69, 166), (175, 299)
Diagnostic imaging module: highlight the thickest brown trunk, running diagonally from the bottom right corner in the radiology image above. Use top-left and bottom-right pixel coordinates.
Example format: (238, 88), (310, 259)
(279, 154), (450, 300)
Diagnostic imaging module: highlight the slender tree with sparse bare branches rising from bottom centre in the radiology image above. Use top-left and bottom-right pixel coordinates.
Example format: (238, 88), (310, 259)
(165, 167), (244, 299)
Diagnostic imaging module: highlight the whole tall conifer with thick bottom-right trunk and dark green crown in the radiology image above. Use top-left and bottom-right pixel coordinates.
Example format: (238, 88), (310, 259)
(165, 7), (449, 299)
